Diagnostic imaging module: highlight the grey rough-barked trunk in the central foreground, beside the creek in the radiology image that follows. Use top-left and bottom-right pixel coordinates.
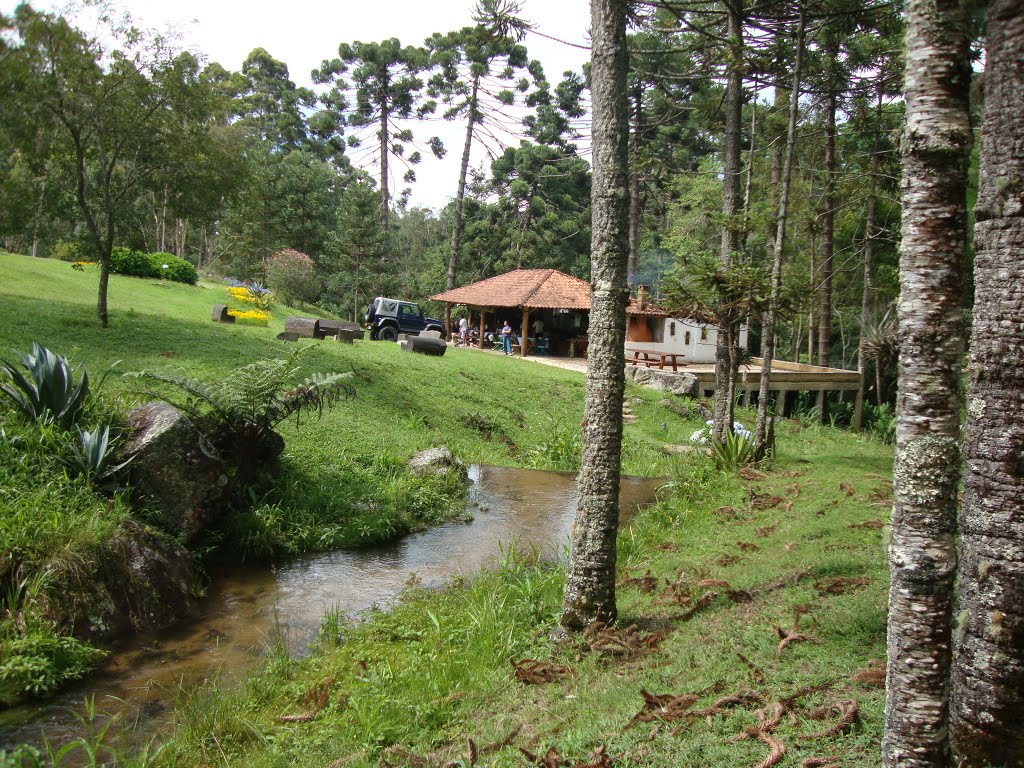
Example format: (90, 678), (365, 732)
(559, 0), (629, 634)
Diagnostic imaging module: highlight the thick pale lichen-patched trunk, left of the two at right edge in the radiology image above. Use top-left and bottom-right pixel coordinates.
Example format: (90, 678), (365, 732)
(882, 0), (973, 768)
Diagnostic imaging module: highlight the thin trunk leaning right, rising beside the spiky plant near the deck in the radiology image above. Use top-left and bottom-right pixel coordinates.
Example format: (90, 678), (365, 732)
(754, 2), (811, 459)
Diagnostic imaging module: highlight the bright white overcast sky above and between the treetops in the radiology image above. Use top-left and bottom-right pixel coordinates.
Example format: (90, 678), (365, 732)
(0, 0), (590, 209)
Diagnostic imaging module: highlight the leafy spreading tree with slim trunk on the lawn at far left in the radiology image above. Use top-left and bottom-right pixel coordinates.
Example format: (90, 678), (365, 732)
(0, 4), (214, 328)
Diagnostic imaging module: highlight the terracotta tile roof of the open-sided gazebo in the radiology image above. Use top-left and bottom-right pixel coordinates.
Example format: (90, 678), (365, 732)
(430, 269), (590, 309)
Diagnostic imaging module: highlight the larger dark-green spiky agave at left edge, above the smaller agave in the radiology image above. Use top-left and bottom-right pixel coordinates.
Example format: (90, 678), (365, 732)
(0, 342), (89, 427)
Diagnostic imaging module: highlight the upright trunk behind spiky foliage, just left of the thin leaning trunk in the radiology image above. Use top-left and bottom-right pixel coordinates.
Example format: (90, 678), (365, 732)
(713, 0), (743, 442)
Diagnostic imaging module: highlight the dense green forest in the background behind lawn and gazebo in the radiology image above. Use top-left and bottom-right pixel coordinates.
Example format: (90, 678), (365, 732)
(0, 0), (921, 401)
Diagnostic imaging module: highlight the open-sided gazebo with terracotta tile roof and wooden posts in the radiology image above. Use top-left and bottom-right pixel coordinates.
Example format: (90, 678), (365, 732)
(430, 269), (590, 356)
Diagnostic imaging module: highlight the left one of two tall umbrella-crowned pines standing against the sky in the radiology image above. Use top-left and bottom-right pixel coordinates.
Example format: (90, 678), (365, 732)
(313, 38), (444, 232)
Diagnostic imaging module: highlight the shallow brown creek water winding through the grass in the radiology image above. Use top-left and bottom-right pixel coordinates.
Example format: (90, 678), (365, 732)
(0, 466), (664, 749)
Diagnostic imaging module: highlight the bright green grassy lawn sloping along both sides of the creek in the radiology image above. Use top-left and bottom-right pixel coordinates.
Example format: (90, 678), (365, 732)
(0, 254), (892, 766)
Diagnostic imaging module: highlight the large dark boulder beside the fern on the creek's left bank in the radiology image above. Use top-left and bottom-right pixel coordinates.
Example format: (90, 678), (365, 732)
(124, 402), (229, 541)
